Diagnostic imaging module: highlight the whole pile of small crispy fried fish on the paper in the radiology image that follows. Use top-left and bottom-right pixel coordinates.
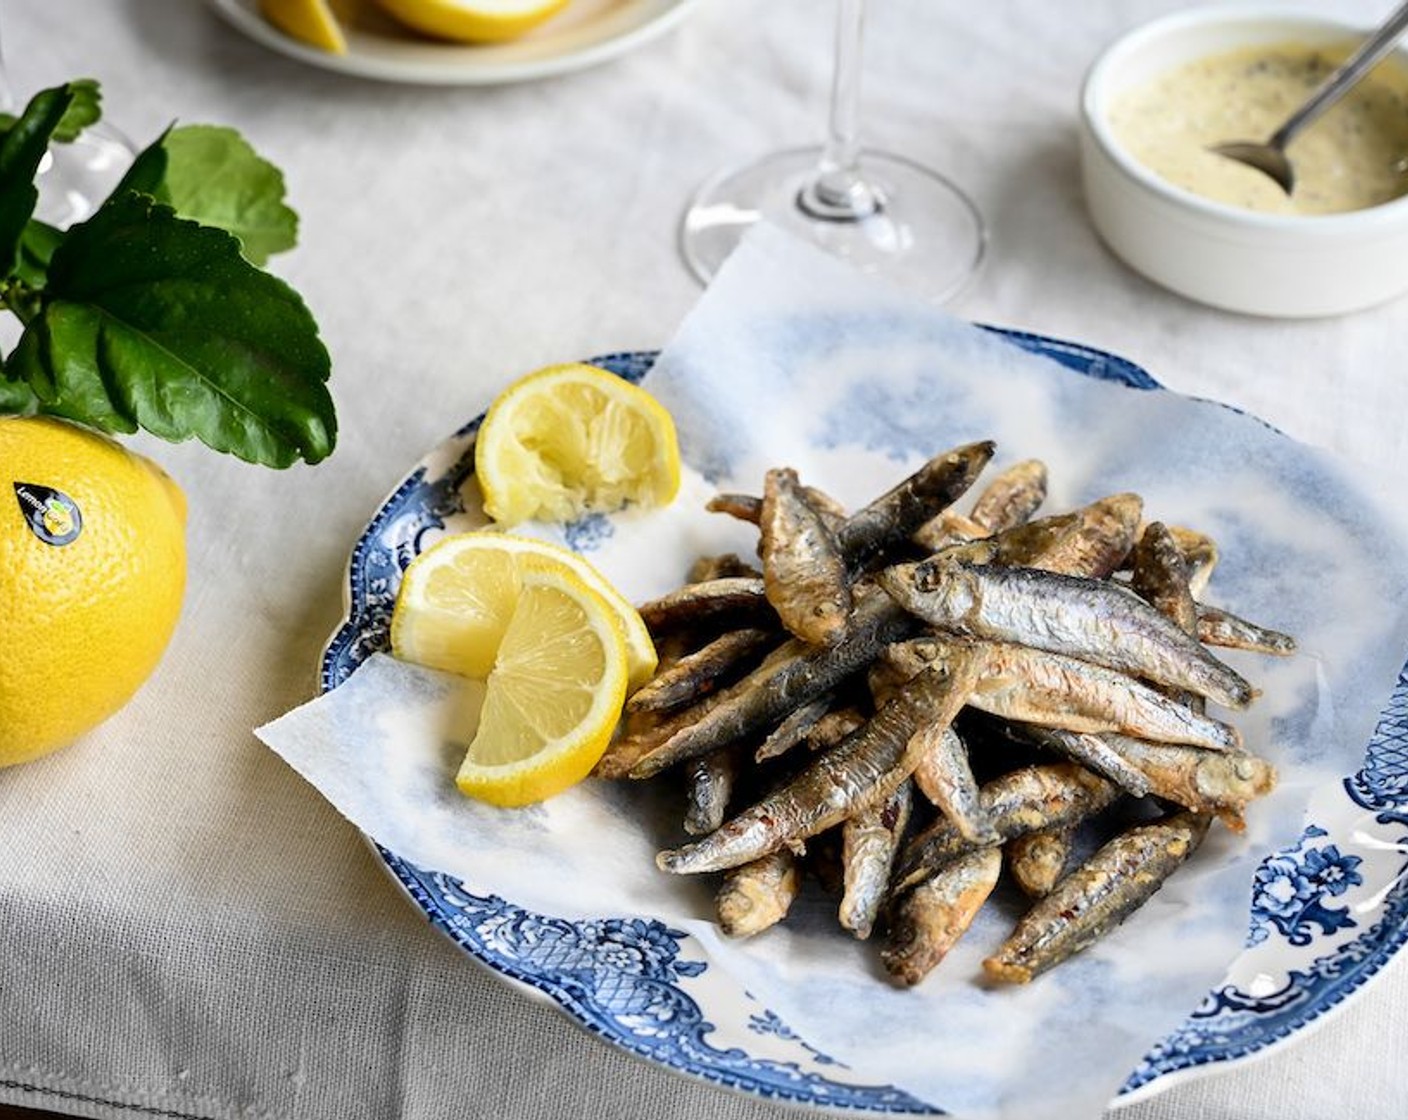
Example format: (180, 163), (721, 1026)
(597, 441), (1295, 985)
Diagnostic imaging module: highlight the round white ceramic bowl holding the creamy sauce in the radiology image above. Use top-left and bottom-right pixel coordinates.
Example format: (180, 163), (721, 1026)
(1080, 6), (1408, 317)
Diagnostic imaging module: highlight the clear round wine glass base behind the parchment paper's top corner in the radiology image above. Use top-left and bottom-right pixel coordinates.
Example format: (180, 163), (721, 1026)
(680, 148), (987, 303)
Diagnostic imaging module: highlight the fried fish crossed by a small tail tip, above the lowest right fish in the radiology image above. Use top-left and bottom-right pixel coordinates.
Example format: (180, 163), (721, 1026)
(890, 762), (1119, 893)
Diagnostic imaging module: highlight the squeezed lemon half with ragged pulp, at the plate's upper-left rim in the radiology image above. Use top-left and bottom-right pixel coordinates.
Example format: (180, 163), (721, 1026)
(474, 363), (680, 525)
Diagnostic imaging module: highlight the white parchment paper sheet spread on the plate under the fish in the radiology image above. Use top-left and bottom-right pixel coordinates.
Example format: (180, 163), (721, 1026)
(258, 228), (1408, 1120)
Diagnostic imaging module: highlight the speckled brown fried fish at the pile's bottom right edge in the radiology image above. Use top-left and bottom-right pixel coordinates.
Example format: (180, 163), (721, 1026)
(983, 813), (1208, 983)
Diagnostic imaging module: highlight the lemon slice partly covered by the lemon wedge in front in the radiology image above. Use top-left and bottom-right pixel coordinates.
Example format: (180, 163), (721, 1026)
(391, 530), (656, 689)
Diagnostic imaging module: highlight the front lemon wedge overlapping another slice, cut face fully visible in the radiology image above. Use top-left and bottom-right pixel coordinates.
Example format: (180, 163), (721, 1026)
(455, 556), (627, 806)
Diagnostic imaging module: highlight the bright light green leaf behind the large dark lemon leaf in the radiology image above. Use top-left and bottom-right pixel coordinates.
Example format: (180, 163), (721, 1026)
(151, 124), (298, 265)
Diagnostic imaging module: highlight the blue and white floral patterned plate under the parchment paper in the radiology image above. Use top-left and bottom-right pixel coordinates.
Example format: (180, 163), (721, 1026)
(320, 339), (1408, 1114)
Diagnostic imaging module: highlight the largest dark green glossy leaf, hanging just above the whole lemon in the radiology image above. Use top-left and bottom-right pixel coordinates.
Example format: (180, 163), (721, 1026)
(8, 192), (337, 466)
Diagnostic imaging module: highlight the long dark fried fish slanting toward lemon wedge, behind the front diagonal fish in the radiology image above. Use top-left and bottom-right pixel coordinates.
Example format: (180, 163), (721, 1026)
(631, 595), (917, 778)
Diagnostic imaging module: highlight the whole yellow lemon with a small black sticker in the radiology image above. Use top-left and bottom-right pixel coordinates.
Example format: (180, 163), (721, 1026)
(0, 417), (186, 766)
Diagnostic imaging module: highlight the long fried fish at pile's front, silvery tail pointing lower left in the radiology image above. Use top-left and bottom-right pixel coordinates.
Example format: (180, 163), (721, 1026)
(656, 672), (963, 875)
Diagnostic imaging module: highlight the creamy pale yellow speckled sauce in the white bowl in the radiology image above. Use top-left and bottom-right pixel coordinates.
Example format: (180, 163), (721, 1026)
(1110, 42), (1408, 214)
